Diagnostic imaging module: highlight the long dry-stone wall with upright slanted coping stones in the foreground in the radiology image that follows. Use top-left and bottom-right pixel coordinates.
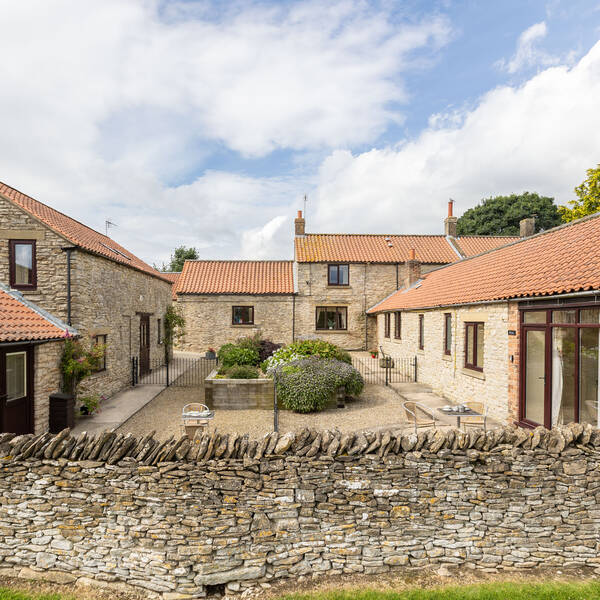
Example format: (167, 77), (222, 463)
(0, 425), (600, 599)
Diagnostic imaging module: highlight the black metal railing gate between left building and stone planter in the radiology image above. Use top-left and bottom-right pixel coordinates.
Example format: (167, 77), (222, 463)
(131, 354), (217, 387)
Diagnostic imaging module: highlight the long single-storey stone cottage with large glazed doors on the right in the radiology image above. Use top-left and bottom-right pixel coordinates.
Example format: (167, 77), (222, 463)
(369, 213), (600, 428)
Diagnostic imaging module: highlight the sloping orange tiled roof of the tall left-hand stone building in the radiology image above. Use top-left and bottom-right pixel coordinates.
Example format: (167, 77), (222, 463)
(0, 182), (172, 279)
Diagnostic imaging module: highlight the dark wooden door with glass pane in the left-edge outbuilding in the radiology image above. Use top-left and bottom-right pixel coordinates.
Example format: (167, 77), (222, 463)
(0, 346), (34, 434)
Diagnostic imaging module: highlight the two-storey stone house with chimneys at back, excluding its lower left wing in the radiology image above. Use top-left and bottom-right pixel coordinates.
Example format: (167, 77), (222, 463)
(294, 202), (518, 350)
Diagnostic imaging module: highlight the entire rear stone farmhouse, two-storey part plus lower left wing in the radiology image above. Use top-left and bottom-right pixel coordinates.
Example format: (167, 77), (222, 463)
(174, 203), (518, 352)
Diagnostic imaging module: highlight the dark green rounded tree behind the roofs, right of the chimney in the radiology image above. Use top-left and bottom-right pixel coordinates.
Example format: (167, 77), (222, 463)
(456, 192), (561, 235)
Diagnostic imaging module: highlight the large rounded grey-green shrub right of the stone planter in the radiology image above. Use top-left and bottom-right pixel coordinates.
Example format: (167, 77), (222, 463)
(274, 356), (364, 413)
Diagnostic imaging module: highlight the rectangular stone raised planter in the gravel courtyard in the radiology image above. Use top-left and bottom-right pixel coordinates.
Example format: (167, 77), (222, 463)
(204, 369), (281, 410)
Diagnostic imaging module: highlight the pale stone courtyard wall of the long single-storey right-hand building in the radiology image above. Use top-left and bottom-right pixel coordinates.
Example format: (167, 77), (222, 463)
(378, 303), (510, 422)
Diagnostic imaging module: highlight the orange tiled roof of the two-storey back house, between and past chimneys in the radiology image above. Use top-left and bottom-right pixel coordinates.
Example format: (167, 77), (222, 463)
(295, 233), (519, 264)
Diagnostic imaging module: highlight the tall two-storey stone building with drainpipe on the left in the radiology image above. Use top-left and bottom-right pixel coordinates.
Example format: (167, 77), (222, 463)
(0, 179), (172, 418)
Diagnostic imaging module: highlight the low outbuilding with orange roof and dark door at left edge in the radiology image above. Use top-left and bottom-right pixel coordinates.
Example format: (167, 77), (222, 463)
(0, 284), (77, 434)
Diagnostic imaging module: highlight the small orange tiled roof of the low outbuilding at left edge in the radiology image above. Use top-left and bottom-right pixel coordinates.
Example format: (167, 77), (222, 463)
(0, 284), (77, 343)
